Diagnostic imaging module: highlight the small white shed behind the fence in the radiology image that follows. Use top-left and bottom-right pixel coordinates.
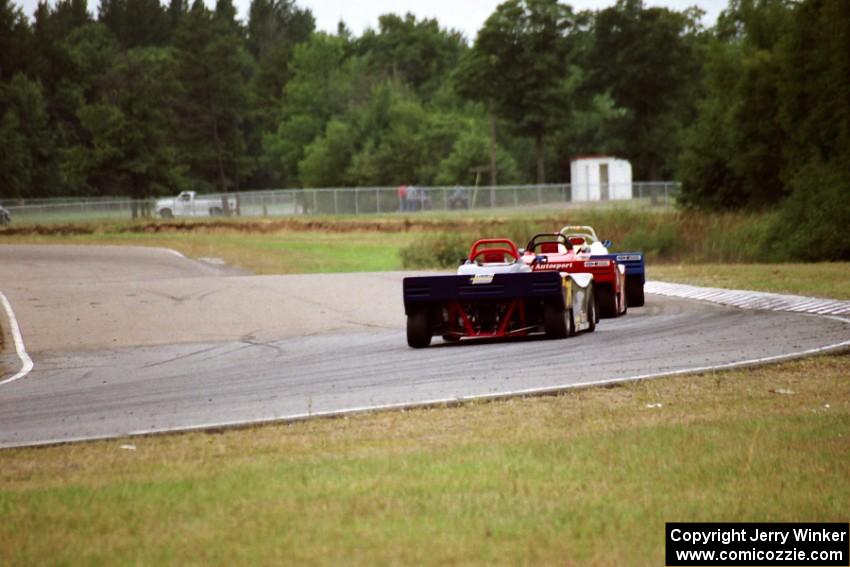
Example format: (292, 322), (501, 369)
(570, 156), (632, 201)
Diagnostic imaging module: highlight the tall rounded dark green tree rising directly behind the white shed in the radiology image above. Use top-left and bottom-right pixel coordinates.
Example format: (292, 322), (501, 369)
(586, 0), (701, 180)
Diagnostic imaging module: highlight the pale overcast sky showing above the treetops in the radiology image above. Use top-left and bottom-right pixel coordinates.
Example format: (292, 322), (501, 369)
(13, 0), (728, 40)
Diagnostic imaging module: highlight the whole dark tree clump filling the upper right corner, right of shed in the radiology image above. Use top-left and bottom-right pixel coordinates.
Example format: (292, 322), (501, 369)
(680, 0), (850, 259)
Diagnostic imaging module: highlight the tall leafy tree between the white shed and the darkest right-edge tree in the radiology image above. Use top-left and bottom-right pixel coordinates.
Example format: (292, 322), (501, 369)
(681, 0), (791, 208)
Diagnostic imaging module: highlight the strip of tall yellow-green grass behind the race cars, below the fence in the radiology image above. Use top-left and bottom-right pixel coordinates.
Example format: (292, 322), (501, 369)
(0, 208), (808, 273)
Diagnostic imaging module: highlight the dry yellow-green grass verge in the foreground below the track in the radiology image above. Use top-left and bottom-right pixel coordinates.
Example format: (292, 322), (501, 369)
(0, 355), (850, 565)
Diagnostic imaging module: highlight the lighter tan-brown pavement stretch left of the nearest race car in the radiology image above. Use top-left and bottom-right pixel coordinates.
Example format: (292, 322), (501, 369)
(0, 245), (410, 354)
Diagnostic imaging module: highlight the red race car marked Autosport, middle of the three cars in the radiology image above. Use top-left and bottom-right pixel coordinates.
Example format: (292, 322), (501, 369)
(523, 232), (628, 318)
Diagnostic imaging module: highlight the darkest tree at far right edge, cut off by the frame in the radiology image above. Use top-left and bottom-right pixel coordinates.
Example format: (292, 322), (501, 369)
(771, 0), (850, 260)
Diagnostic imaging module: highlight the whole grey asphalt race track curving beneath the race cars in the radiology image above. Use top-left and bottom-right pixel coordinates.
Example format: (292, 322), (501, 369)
(0, 246), (850, 447)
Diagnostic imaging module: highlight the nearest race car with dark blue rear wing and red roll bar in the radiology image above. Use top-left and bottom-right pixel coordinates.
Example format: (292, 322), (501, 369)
(403, 238), (598, 348)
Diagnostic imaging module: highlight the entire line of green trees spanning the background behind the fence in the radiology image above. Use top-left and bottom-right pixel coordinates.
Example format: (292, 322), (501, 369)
(0, 0), (850, 245)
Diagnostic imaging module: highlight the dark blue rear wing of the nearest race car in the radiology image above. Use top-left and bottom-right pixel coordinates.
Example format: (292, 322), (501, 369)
(403, 271), (564, 315)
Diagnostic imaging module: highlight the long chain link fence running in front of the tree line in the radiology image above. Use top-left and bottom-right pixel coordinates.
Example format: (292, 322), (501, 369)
(0, 182), (679, 224)
